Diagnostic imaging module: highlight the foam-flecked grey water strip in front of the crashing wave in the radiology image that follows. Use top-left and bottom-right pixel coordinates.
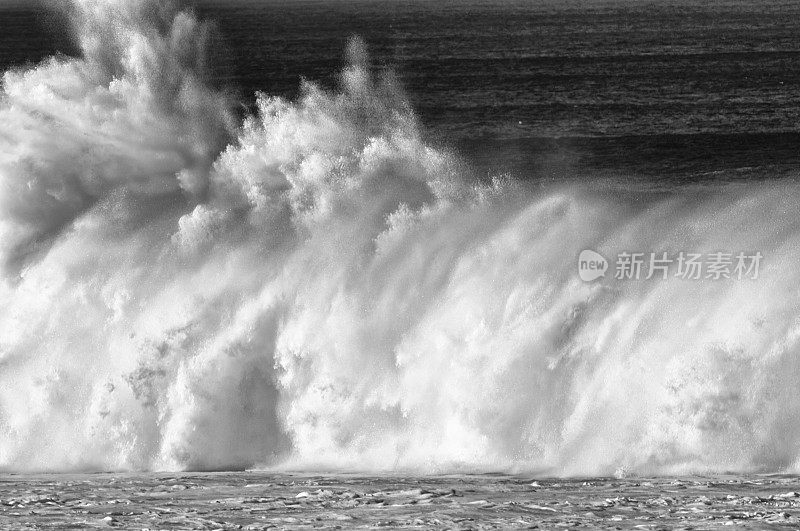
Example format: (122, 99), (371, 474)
(0, 473), (800, 530)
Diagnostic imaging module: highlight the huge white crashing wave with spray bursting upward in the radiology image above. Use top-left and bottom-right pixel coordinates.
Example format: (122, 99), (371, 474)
(0, 0), (800, 475)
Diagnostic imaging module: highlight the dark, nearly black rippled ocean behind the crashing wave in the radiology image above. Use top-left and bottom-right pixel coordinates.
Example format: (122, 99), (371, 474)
(0, 0), (800, 180)
